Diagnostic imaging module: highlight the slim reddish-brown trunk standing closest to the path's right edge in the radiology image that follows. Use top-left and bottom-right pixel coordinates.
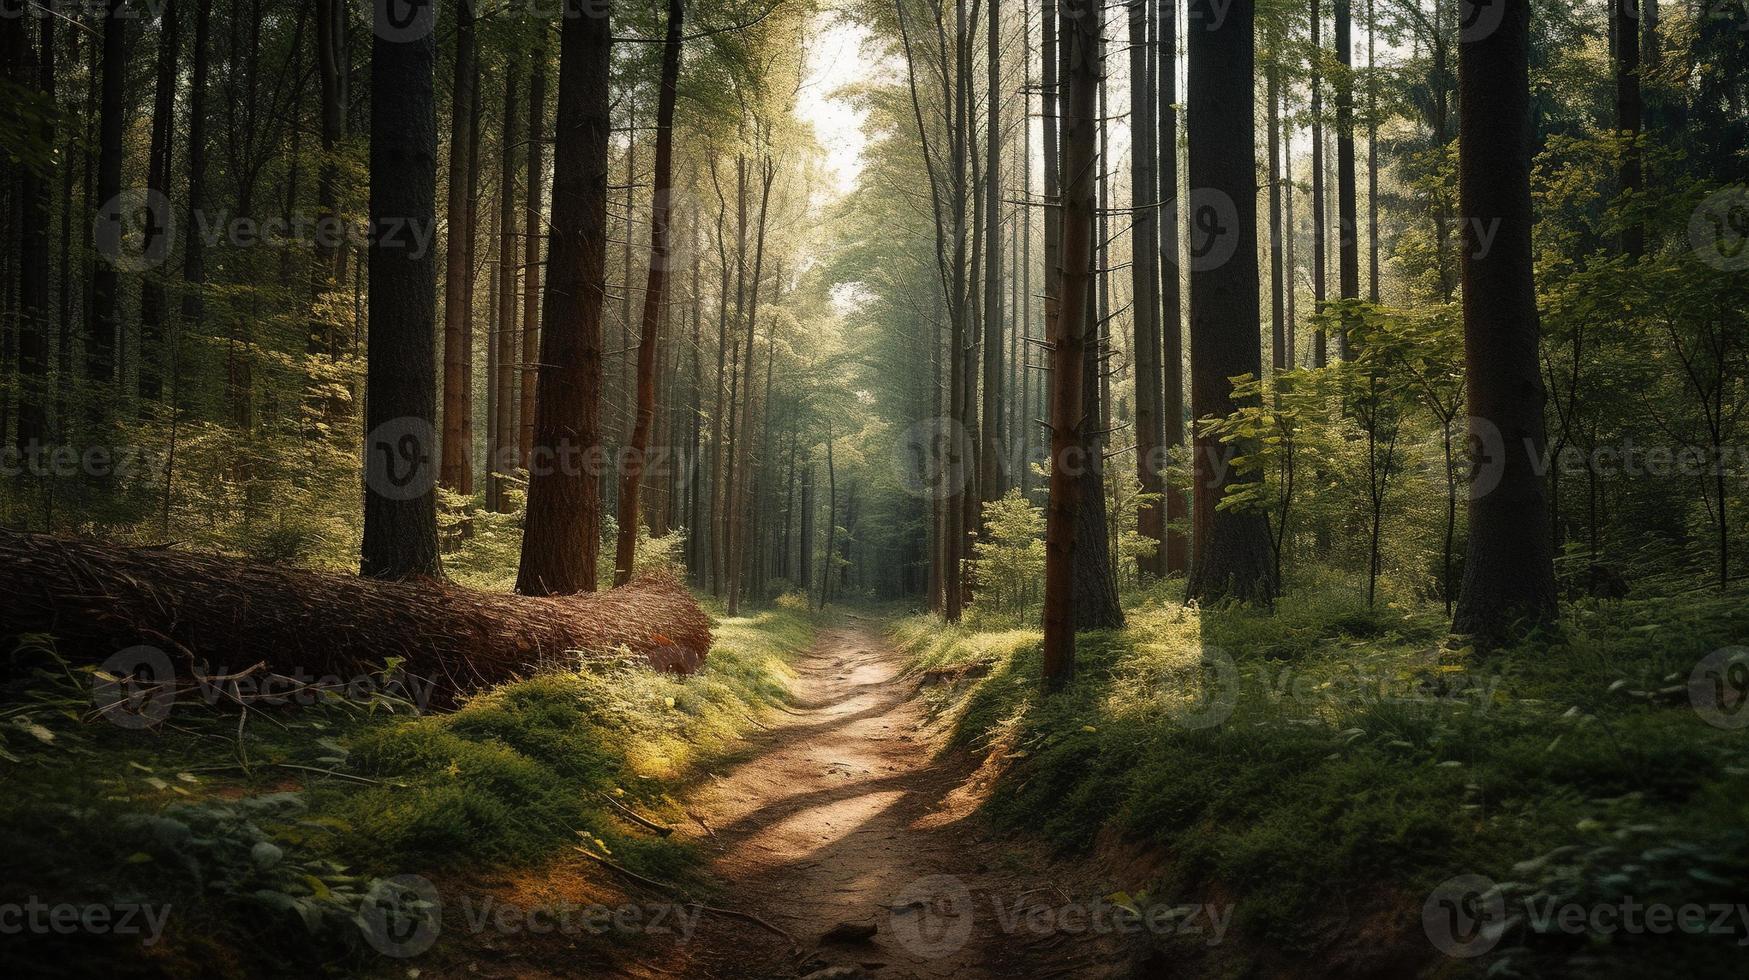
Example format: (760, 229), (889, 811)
(1044, 0), (1104, 690)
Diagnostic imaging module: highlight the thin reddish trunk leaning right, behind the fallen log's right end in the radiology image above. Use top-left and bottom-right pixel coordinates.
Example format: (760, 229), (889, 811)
(614, 0), (686, 586)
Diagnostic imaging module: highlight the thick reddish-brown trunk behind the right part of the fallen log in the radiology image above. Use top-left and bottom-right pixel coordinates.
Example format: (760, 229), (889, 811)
(516, 0), (612, 595)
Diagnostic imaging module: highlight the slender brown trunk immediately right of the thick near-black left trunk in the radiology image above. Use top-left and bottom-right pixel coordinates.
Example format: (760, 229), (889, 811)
(442, 2), (477, 494)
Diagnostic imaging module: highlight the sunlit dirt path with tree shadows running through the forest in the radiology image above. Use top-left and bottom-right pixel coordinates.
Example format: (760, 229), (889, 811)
(630, 614), (1111, 980)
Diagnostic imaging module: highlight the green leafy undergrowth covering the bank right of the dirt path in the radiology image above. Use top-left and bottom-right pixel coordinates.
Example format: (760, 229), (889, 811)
(894, 581), (1749, 975)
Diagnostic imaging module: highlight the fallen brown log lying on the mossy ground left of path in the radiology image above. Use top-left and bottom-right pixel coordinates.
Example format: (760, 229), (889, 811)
(0, 532), (710, 704)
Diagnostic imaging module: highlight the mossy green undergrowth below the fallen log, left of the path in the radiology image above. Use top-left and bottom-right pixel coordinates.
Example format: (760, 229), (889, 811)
(0, 609), (813, 977)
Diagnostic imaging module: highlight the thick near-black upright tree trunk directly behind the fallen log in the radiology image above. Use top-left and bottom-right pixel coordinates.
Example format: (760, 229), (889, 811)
(362, 5), (442, 579)
